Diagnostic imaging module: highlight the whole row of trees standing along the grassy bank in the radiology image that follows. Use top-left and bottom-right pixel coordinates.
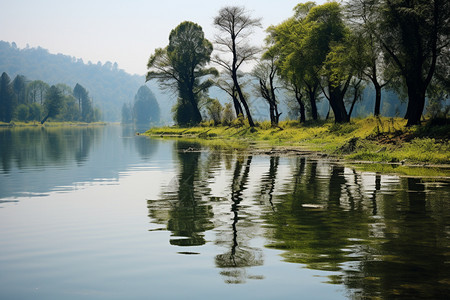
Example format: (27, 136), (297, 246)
(146, 0), (450, 126)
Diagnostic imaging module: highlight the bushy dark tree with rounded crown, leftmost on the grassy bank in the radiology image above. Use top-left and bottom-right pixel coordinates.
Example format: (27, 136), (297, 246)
(146, 21), (217, 126)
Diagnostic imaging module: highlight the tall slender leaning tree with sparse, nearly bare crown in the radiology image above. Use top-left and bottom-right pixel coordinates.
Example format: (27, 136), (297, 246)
(213, 6), (261, 127)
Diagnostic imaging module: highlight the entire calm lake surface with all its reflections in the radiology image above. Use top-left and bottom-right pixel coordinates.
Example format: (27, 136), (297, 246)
(0, 125), (450, 299)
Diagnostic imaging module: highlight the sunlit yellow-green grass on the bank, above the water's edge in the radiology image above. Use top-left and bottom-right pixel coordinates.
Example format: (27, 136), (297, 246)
(145, 117), (450, 165)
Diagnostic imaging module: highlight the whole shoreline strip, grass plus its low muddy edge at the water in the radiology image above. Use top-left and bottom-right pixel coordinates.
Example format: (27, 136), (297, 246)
(142, 117), (450, 178)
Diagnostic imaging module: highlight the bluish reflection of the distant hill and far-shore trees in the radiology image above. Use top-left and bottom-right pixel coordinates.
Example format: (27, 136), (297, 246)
(0, 125), (159, 202)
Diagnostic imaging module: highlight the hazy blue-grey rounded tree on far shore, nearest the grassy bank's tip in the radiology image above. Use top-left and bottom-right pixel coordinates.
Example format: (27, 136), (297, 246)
(132, 85), (159, 125)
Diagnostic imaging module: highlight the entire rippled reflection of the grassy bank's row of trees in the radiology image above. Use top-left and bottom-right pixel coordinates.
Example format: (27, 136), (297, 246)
(148, 142), (450, 299)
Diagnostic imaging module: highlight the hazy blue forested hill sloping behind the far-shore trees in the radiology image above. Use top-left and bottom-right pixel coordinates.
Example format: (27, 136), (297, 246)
(0, 41), (175, 123)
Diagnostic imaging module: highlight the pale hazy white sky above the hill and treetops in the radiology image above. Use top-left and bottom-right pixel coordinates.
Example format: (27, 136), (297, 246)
(0, 0), (326, 75)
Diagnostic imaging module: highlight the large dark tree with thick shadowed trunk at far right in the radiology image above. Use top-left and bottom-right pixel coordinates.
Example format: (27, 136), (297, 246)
(361, 0), (450, 126)
